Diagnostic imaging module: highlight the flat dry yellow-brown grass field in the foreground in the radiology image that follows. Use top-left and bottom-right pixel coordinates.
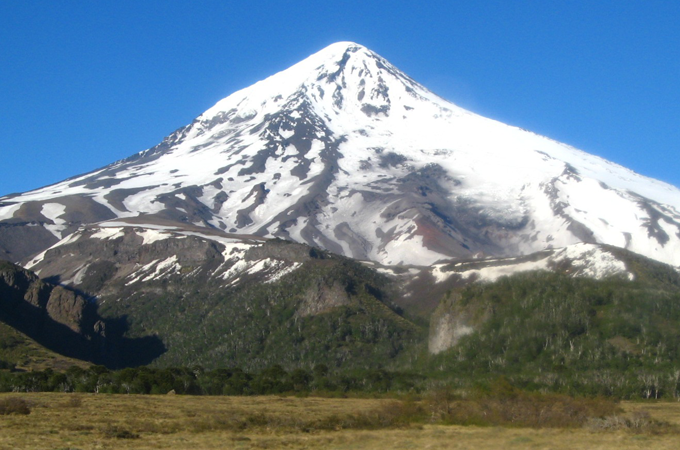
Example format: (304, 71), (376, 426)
(0, 393), (680, 450)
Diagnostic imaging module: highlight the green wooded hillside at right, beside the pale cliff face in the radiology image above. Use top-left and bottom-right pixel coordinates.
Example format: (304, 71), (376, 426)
(423, 272), (680, 398)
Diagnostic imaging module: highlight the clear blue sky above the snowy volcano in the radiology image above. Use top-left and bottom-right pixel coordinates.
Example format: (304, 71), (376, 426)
(0, 0), (680, 195)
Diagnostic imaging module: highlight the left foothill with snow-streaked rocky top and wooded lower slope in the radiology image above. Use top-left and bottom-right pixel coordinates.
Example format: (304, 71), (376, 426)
(19, 221), (425, 370)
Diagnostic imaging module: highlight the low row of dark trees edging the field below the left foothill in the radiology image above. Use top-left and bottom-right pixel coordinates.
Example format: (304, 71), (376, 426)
(0, 364), (424, 395)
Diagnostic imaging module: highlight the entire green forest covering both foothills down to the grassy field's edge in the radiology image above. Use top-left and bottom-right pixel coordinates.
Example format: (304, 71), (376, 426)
(0, 246), (680, 399)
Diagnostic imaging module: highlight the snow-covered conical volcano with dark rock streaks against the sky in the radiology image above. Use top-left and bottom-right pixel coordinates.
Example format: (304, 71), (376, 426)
(0, 42), (680, 265)
